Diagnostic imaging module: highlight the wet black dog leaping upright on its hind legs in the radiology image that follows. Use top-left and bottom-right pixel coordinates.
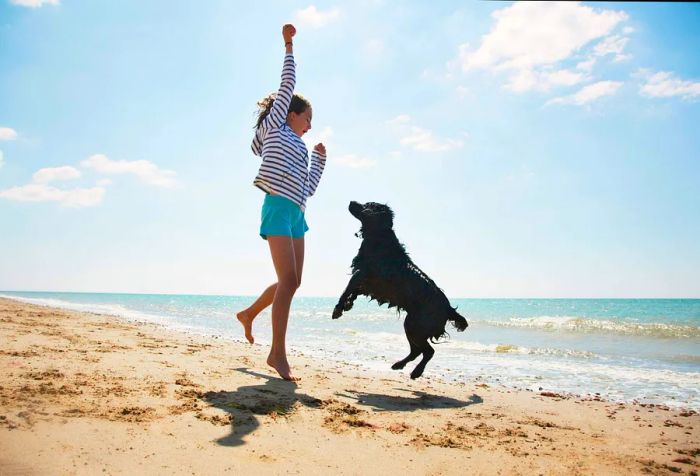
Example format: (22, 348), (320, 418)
(333, 202), (468, 378)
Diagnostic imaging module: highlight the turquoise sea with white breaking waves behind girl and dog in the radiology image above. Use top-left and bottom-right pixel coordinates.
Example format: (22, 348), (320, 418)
(0, 292), (700, 410)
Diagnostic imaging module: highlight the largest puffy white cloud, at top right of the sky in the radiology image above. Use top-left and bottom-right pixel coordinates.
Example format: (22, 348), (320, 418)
(456, 2), (628, 92)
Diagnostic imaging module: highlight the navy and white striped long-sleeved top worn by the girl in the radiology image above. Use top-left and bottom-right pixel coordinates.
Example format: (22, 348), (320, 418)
(251, 54), (326, 210)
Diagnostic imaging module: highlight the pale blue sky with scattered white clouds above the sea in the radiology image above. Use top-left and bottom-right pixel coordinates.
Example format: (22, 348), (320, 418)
(0, 0), (700, 298)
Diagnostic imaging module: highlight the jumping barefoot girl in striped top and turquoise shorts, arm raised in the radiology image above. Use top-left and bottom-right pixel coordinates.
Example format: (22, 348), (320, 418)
(237, 24), (326, 381)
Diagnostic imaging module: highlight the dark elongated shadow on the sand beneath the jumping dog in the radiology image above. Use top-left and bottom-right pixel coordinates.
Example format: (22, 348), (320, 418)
(336, 388), (484, 411)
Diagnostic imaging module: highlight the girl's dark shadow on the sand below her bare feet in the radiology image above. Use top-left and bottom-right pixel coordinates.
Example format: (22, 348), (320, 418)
(201, 367), (321, 446)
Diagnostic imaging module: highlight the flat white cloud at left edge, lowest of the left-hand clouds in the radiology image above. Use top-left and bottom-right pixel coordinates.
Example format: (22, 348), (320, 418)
(0, 183), (105, 208)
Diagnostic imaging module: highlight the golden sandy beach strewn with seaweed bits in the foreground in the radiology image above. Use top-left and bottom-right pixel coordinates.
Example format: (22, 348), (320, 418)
(0, 299), (700, 475)
